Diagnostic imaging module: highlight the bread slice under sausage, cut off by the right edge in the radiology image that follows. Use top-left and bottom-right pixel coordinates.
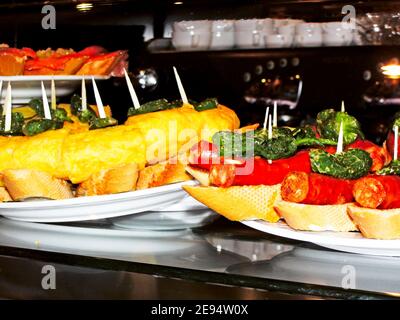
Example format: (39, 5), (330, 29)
(348, 204), (400, 240)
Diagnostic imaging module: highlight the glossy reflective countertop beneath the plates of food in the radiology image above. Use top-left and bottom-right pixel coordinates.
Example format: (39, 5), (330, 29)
(0, 218), (400, 299)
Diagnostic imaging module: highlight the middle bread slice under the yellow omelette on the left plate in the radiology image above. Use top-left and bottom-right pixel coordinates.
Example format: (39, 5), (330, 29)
(76, 163), (139, 197)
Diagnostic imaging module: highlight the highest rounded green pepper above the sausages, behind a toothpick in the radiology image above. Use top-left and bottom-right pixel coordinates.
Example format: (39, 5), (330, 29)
(317, 109), (364, 145)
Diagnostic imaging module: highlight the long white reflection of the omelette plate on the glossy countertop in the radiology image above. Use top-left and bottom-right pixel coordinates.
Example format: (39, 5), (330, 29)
(0, 217), (249, 272)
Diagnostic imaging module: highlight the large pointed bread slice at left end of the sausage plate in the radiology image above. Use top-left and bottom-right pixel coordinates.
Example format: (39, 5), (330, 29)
(183, 184), (281, 222)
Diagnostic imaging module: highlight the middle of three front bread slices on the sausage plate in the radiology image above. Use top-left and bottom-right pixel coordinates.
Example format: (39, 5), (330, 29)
(275, 201), (357, 232)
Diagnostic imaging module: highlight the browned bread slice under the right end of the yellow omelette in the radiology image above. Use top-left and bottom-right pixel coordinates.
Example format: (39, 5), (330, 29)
(137, 161), (192, 190)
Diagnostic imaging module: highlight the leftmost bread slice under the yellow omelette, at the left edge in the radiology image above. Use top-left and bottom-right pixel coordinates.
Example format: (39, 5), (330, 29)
(3, 169), (74, 200)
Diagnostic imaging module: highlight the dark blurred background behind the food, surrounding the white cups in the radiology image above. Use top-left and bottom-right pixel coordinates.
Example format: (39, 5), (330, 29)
(0, 0), (400, 142)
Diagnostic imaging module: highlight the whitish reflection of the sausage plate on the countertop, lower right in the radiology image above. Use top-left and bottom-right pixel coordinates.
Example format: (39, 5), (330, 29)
(226, 245), (400, 296)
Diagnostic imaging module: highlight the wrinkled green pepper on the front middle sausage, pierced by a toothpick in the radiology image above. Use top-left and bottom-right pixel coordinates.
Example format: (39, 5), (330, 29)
(310, 149), (372, 179)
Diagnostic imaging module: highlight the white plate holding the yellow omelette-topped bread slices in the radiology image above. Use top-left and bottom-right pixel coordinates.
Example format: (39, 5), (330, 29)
(0, 180), (197, 222)
